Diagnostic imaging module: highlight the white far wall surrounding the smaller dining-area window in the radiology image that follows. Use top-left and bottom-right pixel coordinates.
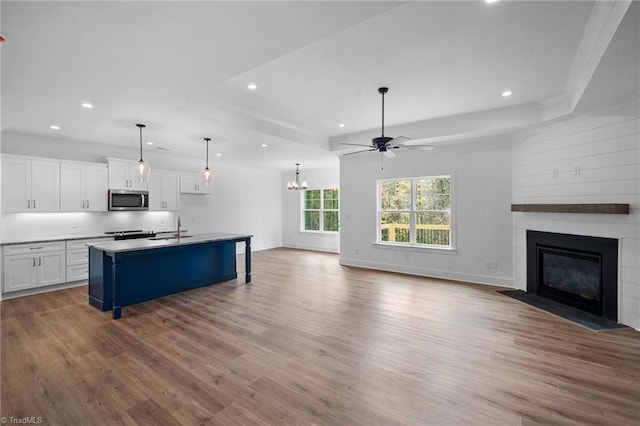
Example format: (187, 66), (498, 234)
(279, 165), (342, 253)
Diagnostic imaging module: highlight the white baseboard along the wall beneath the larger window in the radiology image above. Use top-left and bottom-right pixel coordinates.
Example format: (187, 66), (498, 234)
(340, 257), (515, 288)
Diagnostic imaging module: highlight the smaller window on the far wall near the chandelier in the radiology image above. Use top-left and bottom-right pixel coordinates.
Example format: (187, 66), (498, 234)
(302, 189), (340, 232)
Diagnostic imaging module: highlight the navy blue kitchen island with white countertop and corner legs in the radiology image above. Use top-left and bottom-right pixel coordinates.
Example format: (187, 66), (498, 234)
(88, 233), (252, 319)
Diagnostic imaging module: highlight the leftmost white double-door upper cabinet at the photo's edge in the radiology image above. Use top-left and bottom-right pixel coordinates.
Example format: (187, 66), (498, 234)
(2, 156), (60, 212)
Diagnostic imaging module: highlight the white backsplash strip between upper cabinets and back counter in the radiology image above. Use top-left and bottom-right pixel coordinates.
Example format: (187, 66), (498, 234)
(0, 212), (178, 242)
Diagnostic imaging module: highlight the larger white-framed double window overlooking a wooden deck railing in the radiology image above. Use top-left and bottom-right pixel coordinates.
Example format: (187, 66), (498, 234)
(378, 176), (452, 248)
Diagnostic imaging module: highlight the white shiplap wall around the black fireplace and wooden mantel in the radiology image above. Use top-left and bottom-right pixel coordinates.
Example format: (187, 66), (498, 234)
(513, 99), (640, 329)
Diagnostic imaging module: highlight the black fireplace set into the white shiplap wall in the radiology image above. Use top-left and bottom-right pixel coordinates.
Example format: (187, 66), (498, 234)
(527, 230), (618, 321)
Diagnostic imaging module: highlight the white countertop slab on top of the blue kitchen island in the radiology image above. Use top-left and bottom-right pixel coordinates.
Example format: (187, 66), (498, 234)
(87, 232), (253, 253)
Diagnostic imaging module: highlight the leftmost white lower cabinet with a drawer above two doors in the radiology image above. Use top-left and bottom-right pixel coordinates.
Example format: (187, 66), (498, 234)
(2, 241), (66, 292)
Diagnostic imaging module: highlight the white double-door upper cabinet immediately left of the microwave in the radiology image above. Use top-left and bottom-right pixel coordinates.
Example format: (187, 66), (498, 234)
(60, 162), (108, 212)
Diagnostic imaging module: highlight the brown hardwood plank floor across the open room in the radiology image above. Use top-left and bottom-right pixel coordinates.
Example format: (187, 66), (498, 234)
(1, 249), (640, 425)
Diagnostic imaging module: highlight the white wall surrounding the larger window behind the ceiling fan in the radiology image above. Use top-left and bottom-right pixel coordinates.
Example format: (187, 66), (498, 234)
(340, 136), (513, 286)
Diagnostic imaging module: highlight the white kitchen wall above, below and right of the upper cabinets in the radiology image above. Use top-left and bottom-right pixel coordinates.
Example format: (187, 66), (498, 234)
(0, 132), (282, 250)
